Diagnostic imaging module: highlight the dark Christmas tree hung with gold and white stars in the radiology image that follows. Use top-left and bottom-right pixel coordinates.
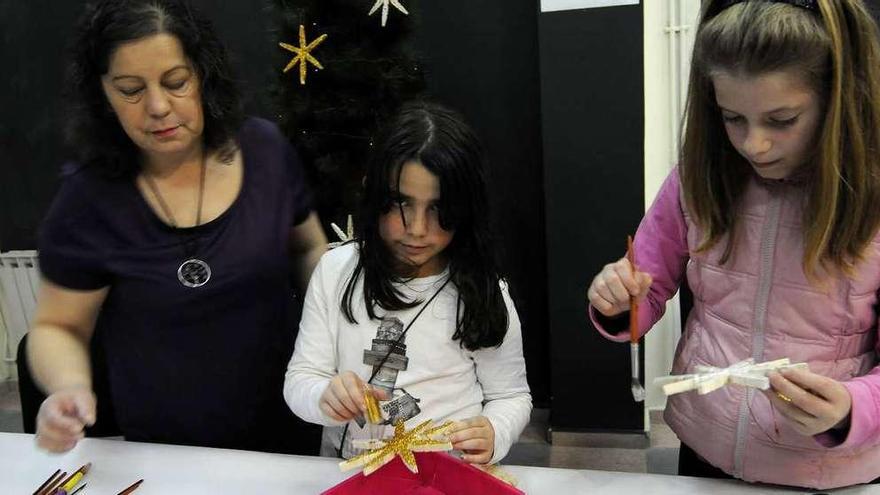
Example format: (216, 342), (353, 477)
(274, 0), (425, 232)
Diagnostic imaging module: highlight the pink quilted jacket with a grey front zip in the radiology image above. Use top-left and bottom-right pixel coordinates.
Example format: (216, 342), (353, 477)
(590, 169), (880, 489)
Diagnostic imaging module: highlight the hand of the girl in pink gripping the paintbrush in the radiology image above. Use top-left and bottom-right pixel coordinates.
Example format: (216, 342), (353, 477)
(587, 258), (653, 317)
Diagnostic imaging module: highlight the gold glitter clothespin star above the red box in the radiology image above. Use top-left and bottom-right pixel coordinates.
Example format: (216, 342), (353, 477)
(339, 419), (452, 476)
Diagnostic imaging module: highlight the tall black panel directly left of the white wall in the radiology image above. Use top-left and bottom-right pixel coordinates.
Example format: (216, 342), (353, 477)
(539, 5), (644, 431)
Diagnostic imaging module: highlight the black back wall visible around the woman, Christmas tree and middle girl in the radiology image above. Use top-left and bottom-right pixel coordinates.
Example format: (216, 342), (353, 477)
(0, 0), (550, 406)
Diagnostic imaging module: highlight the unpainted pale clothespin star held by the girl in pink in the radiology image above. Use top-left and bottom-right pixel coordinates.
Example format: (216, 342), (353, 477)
(654, 358), (808, 395)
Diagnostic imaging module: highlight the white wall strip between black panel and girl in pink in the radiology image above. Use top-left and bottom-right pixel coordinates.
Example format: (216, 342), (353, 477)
(643, 0), (700, 418)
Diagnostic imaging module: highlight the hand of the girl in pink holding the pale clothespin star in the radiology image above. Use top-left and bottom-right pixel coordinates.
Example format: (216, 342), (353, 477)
(765, 369), (852, 436)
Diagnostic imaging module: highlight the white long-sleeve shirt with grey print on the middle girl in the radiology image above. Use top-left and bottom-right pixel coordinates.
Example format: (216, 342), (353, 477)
(284, 244), (532, 463)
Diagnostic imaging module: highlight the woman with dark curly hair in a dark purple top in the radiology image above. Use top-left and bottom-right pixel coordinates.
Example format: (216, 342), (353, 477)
(28, 0), (326, 453)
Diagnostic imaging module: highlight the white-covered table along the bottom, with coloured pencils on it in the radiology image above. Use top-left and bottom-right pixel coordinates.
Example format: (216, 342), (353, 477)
(0, 433), (880, 495)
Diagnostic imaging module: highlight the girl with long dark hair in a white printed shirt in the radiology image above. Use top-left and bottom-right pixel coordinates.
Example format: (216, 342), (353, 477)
(284, 103), (531, 464)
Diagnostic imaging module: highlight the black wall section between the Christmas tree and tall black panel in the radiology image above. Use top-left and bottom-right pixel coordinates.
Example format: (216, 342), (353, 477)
(416, 0), (550, 407)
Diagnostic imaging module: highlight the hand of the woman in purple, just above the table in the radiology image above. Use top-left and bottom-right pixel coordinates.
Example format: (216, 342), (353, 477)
(36, 386), (96, 452)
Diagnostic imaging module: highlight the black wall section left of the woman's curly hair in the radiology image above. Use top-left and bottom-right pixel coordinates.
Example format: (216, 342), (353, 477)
(0, 0), (81, 251)
